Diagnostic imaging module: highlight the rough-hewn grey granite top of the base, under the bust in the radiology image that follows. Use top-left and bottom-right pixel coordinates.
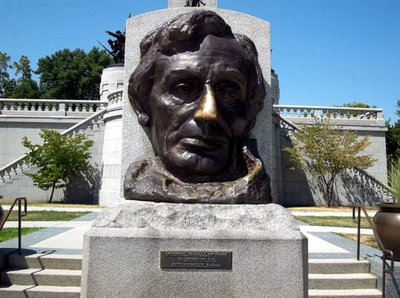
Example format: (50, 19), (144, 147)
(93, 201), (301, 234)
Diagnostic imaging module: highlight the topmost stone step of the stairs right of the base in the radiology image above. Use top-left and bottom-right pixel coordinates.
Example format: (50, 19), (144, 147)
(308, 259), (370, 274)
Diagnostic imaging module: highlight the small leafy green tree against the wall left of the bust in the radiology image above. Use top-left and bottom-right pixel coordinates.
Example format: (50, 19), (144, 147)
(22, 129), (93, 202)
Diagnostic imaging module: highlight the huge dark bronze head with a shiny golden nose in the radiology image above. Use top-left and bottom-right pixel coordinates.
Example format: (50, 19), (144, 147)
(124, 10), (271, 204)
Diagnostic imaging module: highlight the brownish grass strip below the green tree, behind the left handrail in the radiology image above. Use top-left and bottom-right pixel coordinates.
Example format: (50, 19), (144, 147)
(2, 209), (90, 221)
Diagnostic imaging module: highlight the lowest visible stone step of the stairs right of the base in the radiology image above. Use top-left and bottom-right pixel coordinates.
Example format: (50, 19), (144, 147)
(308, 289), (382, 298)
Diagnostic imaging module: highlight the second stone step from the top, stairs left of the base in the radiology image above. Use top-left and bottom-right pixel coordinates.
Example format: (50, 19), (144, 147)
(1, 268), (82, 287)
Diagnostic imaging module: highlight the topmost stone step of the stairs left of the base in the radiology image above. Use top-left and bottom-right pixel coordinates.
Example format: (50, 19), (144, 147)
(9, 254), (82, 270)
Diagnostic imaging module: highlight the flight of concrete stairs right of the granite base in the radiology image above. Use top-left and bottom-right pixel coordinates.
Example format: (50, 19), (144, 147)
(308, 259), (382, 298)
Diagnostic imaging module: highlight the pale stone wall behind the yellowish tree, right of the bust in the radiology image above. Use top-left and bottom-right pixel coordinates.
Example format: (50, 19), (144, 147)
(275, 106), (388, 206)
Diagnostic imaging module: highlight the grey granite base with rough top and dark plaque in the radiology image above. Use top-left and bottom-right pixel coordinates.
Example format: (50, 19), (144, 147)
(81, 201), (308, 298)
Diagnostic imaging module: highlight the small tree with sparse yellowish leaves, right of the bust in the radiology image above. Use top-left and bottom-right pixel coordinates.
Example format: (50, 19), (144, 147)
(283, 119), (374, 207)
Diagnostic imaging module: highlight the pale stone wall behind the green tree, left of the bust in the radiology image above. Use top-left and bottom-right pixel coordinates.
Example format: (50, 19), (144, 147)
(0, 115), (104, 203)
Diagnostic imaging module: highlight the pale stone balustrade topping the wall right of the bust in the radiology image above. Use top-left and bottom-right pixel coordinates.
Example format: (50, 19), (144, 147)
(274, 105), (384, 121)
